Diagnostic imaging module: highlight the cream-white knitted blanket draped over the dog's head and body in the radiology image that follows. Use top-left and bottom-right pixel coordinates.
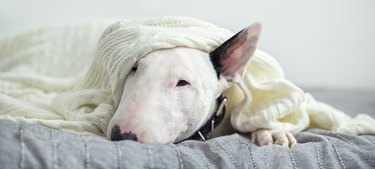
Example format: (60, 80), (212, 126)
(0, 17), (375, 135)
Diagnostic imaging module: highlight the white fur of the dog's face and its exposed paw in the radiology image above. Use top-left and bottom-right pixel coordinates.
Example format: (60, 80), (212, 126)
(107, 48), (296, 146)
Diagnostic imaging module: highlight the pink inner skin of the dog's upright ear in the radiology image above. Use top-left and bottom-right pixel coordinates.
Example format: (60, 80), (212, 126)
(221, 24), (261, 82)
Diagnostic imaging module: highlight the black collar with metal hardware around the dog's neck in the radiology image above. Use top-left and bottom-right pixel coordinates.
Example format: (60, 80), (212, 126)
(186, 95), (227, 141)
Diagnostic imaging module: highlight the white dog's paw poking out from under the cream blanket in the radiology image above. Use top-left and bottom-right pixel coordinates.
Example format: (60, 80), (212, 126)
(251, 129), (297, 148)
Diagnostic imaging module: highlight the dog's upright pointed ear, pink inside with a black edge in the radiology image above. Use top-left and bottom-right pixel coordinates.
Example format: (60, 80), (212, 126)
(210, 23), (261, 83)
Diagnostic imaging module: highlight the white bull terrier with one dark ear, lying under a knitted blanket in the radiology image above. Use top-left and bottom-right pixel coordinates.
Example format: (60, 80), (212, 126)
(107, 23), (296, 147)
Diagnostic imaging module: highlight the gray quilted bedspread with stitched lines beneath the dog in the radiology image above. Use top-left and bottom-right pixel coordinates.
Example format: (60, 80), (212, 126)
(0, 90), (375, 169)
